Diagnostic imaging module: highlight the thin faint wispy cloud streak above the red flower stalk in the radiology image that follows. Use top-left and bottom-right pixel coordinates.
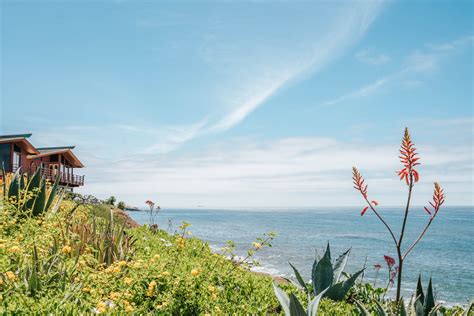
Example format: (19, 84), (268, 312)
(321, 36), (474, 106)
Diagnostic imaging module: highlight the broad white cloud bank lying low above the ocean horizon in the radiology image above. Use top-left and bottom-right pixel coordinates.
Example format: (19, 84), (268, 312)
(81, 133), (474, 207)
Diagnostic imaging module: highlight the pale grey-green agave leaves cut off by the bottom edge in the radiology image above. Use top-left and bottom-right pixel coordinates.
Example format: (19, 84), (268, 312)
(273, 281), (327, 316)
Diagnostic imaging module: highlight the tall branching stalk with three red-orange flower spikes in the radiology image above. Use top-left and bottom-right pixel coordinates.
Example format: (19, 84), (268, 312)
(352, 128), (445, 302)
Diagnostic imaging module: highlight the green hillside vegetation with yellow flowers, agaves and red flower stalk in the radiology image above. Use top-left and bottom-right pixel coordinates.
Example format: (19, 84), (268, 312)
(0, 131), (473, 316)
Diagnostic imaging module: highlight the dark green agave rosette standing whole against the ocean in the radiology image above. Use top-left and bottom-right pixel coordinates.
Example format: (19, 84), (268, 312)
(290, 244), (364, 301)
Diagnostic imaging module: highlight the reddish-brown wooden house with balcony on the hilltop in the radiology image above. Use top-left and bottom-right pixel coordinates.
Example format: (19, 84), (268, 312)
(0, 134), (84, 188)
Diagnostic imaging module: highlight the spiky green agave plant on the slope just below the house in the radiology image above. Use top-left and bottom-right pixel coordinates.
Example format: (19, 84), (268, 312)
(3, 168), (64, 216)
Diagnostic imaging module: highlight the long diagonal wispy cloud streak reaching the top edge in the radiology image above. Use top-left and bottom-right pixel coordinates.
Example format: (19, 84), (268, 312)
(207, 1), (383, 132)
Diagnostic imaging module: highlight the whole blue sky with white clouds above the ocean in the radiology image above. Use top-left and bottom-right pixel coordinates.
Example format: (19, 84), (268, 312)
(0, 0), (474, 208)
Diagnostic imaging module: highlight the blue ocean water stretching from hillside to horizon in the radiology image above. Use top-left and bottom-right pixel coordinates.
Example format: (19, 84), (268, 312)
(129, 207), (474, 305)
